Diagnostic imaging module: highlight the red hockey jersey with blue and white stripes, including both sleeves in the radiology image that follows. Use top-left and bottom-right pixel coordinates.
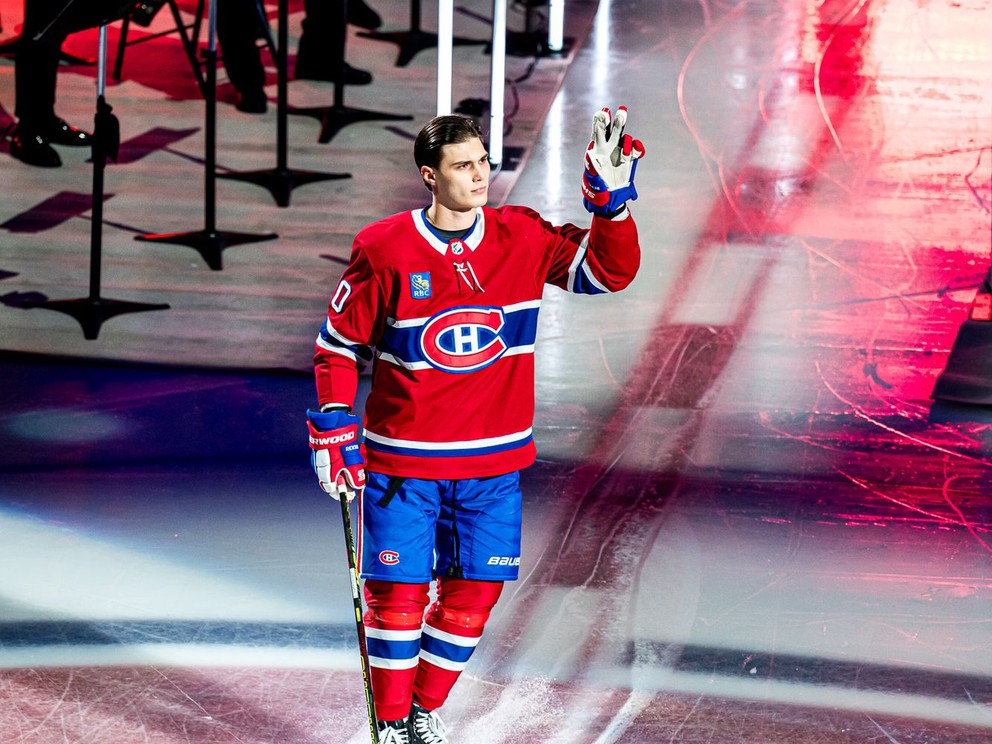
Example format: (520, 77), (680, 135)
(314, 206), (640, 480)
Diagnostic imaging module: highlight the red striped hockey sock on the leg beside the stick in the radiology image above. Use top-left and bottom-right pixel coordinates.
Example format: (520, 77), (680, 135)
(365, 579), (429, 721)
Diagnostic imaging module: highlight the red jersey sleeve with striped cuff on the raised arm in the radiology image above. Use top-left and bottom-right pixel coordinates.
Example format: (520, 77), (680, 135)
(546, 210), (641, 295)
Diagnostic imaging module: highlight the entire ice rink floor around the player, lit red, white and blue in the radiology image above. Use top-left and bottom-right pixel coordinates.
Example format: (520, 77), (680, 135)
(0, 0), (992, 744)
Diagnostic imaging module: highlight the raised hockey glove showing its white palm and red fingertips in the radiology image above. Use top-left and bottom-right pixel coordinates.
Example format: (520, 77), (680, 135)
(582, 106), (644, 217)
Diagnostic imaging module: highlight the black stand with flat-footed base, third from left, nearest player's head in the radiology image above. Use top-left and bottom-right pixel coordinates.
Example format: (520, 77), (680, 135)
(219, 0), (351, 207)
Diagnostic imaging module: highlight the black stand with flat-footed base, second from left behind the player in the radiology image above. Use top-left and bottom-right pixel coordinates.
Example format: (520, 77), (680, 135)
(134, 0), (279, 271)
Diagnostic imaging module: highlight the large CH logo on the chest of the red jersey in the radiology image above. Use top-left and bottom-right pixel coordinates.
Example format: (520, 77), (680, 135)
(420, 307), (509, 372)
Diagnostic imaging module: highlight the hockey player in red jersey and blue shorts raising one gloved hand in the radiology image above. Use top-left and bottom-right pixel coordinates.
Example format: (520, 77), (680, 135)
(307, 107), (644, 744)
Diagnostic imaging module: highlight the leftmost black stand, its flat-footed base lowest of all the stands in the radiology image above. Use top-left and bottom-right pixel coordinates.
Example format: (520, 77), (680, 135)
(23, 23), (169, 340)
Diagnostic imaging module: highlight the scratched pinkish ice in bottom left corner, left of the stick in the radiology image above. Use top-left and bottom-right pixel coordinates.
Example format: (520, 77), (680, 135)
(0, 666), (368, 744)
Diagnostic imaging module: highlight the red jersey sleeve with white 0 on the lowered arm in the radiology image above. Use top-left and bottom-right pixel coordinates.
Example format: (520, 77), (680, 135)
(313, 238), (384, 406)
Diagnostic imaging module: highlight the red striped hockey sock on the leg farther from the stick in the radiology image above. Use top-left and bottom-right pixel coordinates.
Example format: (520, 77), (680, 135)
(413, 578), (503, 710)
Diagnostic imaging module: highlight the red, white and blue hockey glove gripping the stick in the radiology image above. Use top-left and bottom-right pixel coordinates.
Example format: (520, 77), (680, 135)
(307, 409), (365, 501)
